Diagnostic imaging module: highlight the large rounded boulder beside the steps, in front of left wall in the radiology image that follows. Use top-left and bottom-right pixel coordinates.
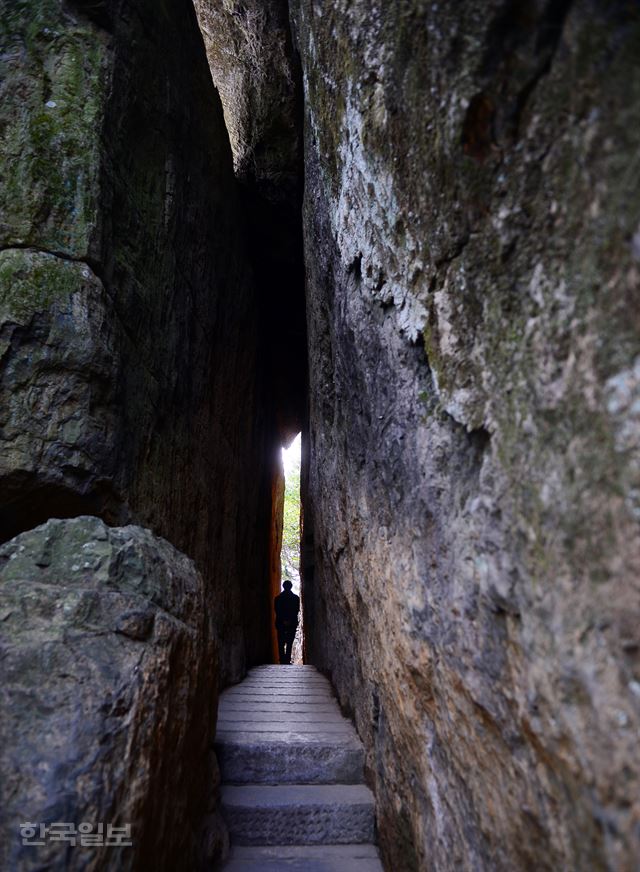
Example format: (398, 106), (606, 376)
(0, 517), (224, 870)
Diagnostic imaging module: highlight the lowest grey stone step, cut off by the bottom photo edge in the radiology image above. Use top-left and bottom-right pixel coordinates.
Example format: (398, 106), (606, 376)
(223, 845), (383, 872)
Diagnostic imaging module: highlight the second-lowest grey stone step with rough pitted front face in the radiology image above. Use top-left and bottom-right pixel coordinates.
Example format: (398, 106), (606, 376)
(222, 784), (375, 845)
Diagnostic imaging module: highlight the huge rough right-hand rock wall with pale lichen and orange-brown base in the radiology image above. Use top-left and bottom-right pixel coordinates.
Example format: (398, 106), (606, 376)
(292, 0), (640, 872)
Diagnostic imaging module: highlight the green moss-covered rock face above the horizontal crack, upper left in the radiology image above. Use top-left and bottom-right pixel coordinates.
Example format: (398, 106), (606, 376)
(0, 0), (107, 256)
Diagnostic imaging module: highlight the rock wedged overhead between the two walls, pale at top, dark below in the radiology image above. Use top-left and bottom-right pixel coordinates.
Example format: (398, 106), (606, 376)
(194, 0), (307, 442)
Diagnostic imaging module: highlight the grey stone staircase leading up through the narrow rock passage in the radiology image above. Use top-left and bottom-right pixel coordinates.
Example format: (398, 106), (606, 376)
(216, 666), (382, 872)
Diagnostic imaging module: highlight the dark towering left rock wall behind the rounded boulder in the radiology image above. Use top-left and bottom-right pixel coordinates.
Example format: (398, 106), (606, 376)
(0, 0), (275, 680)
